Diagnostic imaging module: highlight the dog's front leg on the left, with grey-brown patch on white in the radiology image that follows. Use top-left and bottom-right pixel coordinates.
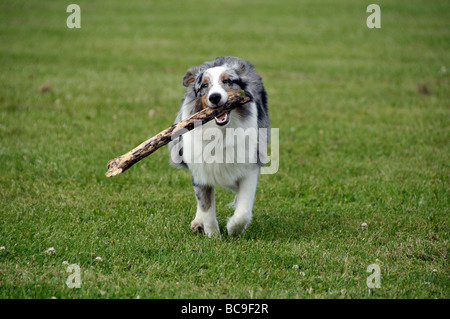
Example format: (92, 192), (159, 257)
(191, 184), (220, 237)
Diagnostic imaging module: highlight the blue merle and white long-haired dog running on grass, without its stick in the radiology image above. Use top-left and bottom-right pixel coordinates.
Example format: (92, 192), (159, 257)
(169, 56), (270, 238)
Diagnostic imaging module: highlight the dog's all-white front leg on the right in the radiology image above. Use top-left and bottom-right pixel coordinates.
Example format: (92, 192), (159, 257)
(227, 168), (259, 236)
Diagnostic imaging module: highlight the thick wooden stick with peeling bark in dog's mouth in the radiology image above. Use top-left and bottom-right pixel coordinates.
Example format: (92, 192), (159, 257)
(105, 94), (250, 177)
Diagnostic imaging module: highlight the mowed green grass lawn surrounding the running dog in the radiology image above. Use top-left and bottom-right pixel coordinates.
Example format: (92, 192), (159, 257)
(0, 0), (450, 298)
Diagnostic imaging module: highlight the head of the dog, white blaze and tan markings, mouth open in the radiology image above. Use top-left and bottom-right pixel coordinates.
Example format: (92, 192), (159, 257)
(183, 65), (245, 126)
